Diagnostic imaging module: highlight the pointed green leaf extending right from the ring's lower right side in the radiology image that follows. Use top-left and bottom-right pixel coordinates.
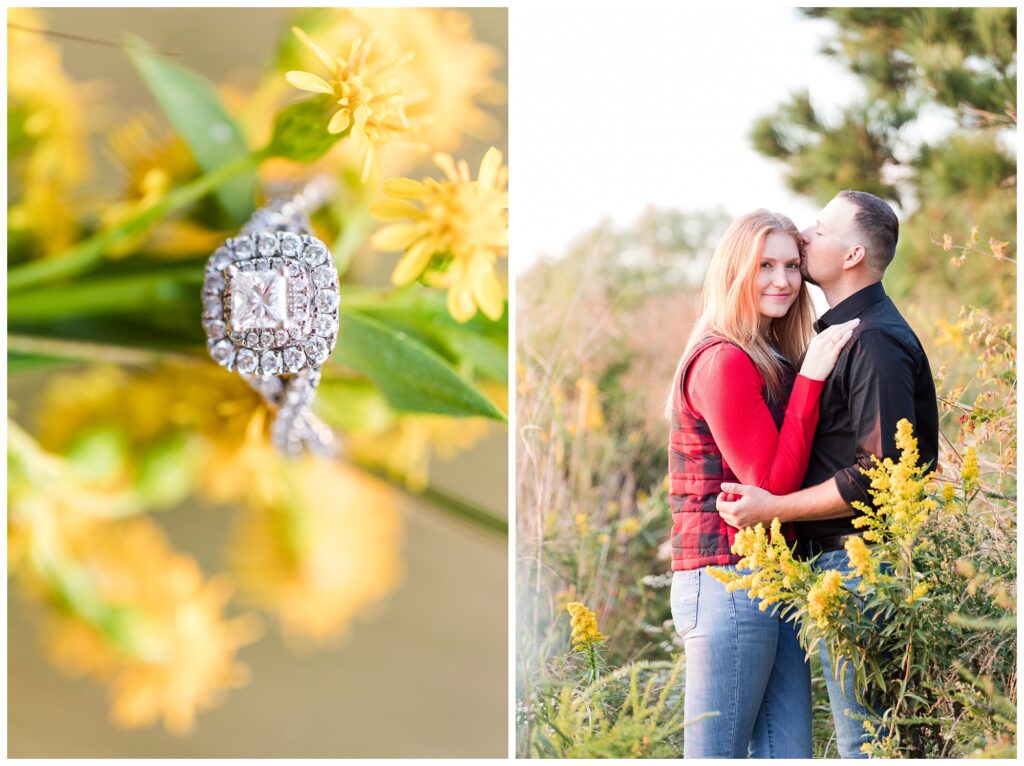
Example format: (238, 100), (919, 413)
(334, 311), (505, 420)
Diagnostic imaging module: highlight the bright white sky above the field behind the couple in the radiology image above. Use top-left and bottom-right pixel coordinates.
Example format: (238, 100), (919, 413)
(509, 3), (862, 271)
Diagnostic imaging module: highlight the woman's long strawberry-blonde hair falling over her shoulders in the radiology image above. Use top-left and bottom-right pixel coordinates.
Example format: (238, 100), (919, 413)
(665, 208), (814, 419)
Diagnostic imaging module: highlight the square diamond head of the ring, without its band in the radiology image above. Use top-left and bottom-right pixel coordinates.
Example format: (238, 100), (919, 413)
(203, 231), (339, 376)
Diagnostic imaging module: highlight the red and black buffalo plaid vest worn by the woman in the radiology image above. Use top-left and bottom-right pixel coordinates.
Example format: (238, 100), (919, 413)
(669, 337), (797, 571)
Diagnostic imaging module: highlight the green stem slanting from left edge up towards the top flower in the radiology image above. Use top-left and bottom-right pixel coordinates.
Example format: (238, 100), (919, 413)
(7, 152), (265, 294)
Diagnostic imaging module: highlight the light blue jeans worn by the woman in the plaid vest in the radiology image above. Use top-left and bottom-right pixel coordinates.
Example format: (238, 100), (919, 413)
(671, 566), (811, 758)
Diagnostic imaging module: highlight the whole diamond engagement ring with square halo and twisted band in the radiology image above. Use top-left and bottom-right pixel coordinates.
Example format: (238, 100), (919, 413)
(203, 179), (339, 456)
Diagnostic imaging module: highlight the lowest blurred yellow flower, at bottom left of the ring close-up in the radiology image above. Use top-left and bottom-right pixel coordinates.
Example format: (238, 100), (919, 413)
(46, 517), (258, 733)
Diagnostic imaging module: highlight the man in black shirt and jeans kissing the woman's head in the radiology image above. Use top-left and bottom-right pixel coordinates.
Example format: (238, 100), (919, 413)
(718, 192), (939, 758)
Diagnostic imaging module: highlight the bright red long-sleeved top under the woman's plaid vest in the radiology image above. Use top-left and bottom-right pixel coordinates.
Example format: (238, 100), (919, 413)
(684, 343), (824, 495)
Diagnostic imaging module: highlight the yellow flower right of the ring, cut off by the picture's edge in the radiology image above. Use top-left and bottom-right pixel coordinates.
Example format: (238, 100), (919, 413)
(371, 146), (508, 322)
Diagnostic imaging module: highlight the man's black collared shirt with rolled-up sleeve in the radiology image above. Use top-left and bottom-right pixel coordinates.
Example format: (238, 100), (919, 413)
(797, 282), (939, 540)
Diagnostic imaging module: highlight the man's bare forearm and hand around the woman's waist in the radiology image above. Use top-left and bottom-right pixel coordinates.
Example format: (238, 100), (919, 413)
(717, 477), (853, 529)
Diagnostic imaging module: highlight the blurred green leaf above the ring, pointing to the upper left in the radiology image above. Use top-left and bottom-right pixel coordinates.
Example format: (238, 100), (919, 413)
(125, 37), (257, 224)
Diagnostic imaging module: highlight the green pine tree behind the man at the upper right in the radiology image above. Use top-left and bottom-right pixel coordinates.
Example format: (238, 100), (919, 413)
(751, 8), (1017, 308)
